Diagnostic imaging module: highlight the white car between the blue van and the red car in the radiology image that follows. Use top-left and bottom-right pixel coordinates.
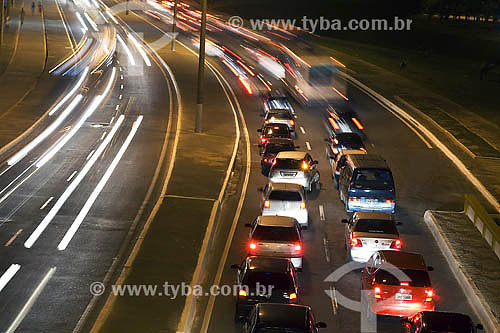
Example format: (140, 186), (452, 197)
(342, 212), (403, 262)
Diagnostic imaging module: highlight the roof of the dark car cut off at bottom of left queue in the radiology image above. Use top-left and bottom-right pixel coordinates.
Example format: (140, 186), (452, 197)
(257, 303), (311, 329)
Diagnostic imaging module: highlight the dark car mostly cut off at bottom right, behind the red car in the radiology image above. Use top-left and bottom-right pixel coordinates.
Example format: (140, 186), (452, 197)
(402, 311), (483, 333)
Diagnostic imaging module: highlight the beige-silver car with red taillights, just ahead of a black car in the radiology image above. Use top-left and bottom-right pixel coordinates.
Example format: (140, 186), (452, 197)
(245, 216), (303, 270)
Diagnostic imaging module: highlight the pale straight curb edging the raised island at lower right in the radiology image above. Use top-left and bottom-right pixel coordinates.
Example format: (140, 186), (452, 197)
(424, 210), (500, 333)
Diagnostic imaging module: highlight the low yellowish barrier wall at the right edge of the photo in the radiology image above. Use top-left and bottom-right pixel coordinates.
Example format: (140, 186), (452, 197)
(464, 194), (500, 259)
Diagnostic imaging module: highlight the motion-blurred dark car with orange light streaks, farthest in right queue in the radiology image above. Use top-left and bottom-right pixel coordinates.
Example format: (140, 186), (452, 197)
(325, 105), (366, 139)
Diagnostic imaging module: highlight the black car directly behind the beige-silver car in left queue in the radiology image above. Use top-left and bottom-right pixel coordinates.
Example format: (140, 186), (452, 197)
(231, 256), (298, 321)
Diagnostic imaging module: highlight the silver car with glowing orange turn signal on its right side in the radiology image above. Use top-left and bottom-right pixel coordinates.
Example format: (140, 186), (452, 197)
(269, 151), (320, 192)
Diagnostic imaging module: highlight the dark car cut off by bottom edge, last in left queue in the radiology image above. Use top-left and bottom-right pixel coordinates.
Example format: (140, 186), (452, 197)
(245, 303), (326, 333)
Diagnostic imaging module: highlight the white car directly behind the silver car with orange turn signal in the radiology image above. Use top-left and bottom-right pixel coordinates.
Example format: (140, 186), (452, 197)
(261, 183), (309, 229)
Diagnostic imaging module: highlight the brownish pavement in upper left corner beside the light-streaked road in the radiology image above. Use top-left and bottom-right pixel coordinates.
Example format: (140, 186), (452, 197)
(0, 0), (71, 151)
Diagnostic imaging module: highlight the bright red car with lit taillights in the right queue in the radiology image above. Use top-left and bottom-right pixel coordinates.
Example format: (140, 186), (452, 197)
(361, 250), (435, 317)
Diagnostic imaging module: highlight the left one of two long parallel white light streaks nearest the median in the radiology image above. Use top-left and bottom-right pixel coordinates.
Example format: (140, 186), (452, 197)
(24, 115), (125, 249)
